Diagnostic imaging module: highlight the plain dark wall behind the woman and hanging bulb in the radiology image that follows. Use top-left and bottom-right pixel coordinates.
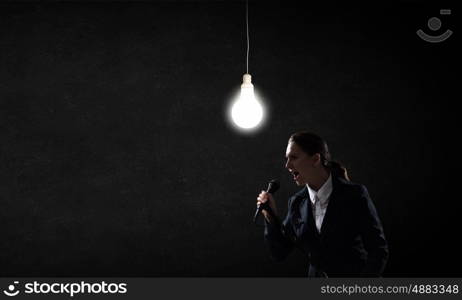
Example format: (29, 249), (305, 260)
(0, 1), (462, 277)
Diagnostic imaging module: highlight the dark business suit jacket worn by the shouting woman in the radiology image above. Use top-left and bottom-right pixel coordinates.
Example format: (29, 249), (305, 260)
(264, 177), (388, 277)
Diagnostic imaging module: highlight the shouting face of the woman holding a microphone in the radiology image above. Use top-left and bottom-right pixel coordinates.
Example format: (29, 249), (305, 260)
(286, 142), (319, 186)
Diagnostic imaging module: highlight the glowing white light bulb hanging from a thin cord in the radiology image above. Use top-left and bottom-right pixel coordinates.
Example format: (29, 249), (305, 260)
(231, 74), (263, 130)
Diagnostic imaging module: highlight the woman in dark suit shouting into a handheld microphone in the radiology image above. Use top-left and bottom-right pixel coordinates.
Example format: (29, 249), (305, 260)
(257, 131), (388, 277)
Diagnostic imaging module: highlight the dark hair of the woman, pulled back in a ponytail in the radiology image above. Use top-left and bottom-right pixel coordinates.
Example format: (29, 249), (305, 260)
(289, 131), (350, 180)
